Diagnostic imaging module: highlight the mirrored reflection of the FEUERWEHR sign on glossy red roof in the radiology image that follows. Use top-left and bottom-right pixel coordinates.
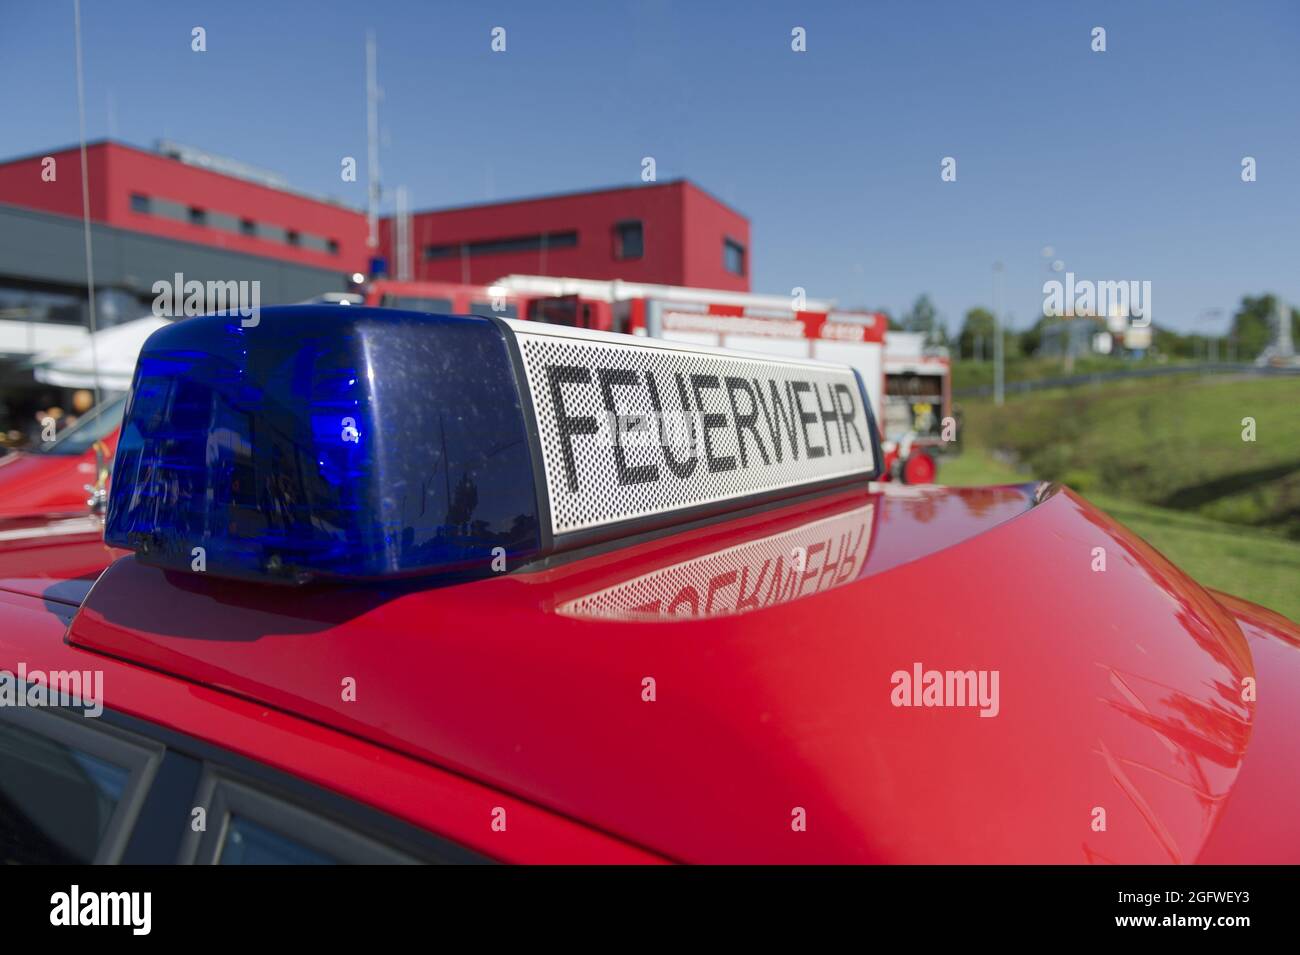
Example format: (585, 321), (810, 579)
(556, 504), (874, 620)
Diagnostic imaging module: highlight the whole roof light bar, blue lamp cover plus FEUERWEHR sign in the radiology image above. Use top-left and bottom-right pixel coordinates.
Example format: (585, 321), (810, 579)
(104, 305), (880, 583)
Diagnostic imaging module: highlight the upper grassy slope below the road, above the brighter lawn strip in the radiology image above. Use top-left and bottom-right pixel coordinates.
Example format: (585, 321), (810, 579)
(961, 376), (1300, 539)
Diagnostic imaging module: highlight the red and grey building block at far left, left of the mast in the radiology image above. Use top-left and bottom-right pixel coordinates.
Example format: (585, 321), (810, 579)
(0, 142), (367, 347)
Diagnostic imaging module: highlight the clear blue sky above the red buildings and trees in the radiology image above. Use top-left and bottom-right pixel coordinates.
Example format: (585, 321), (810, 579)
(0, 0), (1300, 330)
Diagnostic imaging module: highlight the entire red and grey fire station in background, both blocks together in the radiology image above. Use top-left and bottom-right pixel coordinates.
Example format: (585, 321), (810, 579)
(0, 140), (750, 437)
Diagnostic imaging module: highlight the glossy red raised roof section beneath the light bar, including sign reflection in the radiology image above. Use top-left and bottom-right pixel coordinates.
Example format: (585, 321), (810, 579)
(48, 486), (1279, 863)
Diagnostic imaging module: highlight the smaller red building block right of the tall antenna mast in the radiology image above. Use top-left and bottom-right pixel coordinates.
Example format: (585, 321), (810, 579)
(380, 179), (749, 291)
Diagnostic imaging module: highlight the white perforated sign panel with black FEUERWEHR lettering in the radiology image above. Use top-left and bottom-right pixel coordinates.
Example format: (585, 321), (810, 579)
(507, 321), (876, 537)
